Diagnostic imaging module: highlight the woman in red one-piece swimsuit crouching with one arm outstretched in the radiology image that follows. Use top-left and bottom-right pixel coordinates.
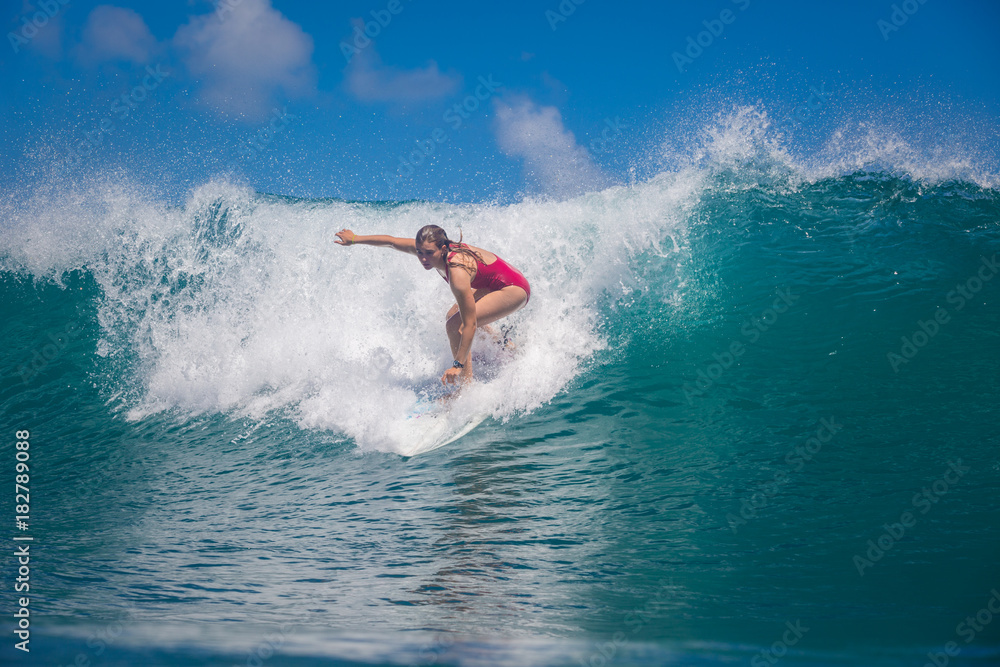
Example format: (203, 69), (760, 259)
(337, 225), (531, 385)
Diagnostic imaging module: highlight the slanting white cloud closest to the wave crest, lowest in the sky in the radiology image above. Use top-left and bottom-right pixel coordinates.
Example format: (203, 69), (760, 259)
(494, 98), (608, 198)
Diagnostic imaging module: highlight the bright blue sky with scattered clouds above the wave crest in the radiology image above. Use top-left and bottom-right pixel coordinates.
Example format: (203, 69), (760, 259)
(0, 0), (1000, 201)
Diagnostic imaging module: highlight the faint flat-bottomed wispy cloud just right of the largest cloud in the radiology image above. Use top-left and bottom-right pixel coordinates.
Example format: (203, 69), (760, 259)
(347, 19), (462, 102)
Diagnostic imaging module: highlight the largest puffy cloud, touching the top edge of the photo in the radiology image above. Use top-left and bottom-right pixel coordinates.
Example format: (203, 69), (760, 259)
(174, 0), (316, 120)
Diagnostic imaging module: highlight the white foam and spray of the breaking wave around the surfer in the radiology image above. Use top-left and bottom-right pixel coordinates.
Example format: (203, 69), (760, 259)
(0, 108), (996, 451)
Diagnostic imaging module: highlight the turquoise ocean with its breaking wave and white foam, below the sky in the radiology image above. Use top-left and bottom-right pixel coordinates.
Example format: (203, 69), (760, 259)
(0, 121), (1000, 667)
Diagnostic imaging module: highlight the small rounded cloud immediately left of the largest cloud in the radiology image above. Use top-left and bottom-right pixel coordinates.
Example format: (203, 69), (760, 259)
(74, 5), (156, 65)
